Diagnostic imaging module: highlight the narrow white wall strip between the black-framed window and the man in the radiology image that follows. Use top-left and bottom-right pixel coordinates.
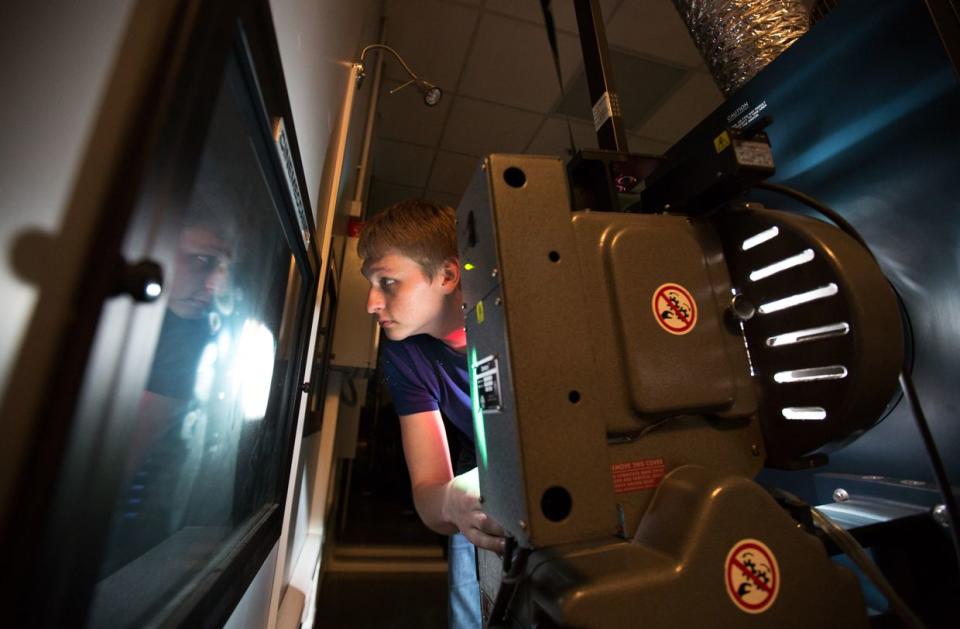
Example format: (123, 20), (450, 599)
(269, 0), (383, 629)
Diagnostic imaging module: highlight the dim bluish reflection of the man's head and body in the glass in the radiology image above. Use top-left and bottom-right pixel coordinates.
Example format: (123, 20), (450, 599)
(103, 194), (237, 574)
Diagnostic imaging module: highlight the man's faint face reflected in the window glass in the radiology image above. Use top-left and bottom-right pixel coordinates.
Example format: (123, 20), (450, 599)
(169, 225), (233, 319)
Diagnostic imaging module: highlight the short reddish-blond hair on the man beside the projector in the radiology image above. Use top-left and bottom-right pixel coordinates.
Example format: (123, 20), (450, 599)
(357, 199), (457, 278)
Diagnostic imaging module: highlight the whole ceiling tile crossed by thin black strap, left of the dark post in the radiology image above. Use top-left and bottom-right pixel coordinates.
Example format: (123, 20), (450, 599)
(458, 13), (581, 113)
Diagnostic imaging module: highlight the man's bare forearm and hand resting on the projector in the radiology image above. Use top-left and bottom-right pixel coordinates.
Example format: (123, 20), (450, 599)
(400, 411), (504, 552)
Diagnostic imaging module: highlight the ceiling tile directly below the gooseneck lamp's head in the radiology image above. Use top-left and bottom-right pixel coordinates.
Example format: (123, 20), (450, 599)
(376, 79), (453, 146)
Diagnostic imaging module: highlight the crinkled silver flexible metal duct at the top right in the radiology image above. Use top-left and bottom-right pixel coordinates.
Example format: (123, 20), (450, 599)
(673, 0), (810, 96)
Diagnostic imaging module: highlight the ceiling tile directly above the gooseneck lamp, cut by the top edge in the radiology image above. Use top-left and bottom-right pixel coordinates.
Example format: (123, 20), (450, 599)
(384, 0), (480, 90)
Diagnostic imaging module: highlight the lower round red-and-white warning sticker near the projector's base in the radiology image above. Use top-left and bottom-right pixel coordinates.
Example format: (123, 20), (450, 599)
(724, 539), (780, 614)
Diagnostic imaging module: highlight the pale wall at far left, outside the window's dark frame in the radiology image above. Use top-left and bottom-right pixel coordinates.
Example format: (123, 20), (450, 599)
(0, 0), (134, 391)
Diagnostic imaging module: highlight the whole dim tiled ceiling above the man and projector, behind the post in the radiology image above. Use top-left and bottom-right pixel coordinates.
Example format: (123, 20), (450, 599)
(368, 0), (723, 213)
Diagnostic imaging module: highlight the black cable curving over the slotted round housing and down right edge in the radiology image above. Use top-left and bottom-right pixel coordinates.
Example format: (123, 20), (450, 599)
(755, 182), (960, 571)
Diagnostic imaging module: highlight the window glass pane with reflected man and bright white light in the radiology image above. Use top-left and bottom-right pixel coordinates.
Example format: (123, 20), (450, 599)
(90, 55), (300, 628)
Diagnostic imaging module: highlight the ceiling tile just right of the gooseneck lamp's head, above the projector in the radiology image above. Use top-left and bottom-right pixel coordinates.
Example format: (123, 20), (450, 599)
(440, 96), (541, 156)
